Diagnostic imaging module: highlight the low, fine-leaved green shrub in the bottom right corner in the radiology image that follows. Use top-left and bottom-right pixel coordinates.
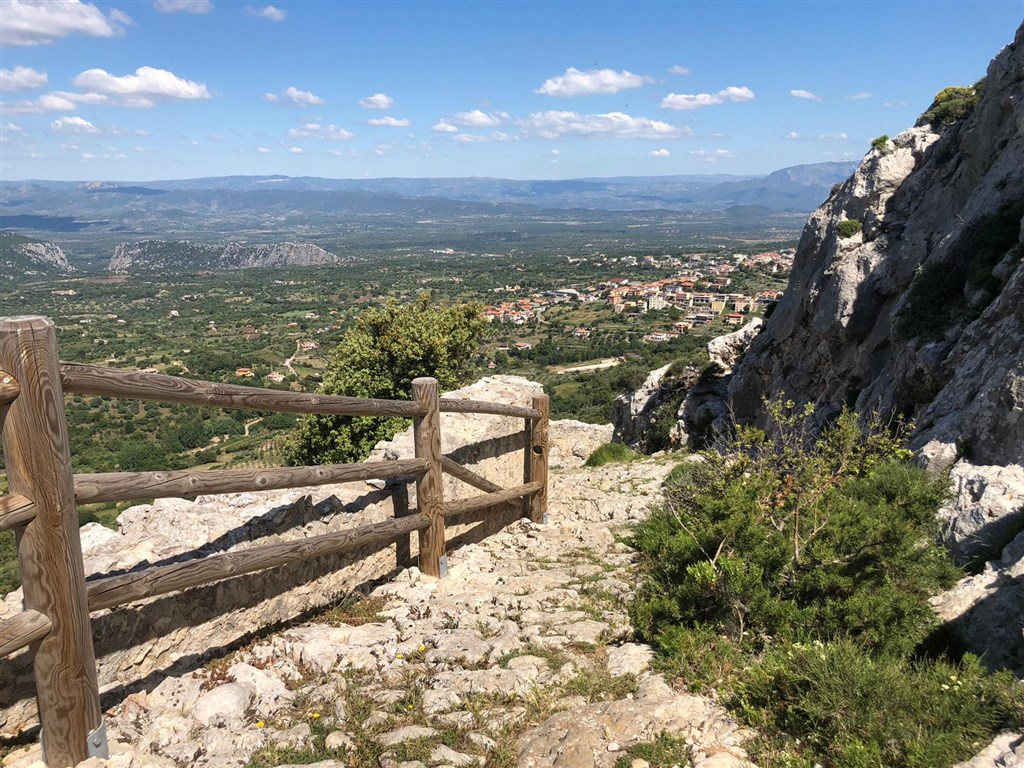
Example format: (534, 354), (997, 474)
(733, 642), (1020, 768)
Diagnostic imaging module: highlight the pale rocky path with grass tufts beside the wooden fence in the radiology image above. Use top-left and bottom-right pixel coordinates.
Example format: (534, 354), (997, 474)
(3, 461), (750, 768)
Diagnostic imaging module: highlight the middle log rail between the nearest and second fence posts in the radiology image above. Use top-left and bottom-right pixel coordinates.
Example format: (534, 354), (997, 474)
(75, 459), (427, 504)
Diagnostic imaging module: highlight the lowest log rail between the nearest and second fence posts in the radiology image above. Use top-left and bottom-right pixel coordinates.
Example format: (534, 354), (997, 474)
(82, 514), (430, 610)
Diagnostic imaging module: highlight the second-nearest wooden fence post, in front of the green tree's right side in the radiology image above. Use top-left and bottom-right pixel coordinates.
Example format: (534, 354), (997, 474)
(413, 378), (447, 577)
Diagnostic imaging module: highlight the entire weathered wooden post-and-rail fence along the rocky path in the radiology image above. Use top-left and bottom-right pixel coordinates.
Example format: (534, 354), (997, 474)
(0, 316), (548, 766)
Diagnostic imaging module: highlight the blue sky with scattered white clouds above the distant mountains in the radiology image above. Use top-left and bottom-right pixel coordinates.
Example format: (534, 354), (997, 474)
(0, 0), (1024, 180)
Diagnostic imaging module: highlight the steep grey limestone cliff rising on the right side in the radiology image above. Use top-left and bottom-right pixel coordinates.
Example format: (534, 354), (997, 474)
(730, 28), (1024, 465)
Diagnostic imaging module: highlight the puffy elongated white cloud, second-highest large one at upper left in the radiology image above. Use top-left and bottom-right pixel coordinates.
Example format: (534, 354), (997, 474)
(72, 67), (212, 109)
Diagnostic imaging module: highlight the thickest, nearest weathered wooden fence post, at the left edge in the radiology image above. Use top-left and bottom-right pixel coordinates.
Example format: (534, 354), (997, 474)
(0, 316), (106, 767)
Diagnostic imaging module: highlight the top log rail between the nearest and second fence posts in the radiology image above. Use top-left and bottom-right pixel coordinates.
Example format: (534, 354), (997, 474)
(60, 362), (422, 418)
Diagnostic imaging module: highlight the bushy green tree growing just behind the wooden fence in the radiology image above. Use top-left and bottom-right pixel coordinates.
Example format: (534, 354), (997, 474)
(288, 294), (485, 464)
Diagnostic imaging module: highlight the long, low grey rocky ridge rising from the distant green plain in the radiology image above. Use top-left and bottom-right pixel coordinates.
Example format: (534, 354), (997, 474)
(106, 240), (346, 272)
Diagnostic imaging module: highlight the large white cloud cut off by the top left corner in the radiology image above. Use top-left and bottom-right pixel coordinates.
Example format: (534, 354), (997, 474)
(0, 0), (132, 45)
